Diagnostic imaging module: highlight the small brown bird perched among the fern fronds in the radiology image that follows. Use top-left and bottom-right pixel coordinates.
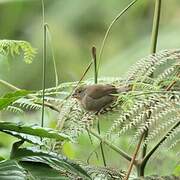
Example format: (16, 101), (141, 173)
(72, 84), (130, 112)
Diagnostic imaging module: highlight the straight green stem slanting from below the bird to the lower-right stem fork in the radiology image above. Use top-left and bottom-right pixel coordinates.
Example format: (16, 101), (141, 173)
(89, 130), (131, 162)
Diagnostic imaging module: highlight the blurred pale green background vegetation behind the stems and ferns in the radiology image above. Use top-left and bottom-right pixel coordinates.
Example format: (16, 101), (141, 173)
(0, 0), (180, 177)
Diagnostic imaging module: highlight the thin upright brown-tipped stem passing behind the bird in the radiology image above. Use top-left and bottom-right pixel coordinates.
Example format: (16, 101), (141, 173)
(92, 46), (106, 167)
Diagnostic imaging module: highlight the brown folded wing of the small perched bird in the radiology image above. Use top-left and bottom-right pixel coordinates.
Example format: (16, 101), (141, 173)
(87, 84), (117, 99)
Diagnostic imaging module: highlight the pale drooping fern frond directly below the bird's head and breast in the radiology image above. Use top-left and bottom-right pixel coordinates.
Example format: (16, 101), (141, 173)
(53, 99), (95, 151)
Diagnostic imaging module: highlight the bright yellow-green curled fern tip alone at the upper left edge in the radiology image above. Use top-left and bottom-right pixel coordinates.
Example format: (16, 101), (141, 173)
(0, 39), (36, 64)
